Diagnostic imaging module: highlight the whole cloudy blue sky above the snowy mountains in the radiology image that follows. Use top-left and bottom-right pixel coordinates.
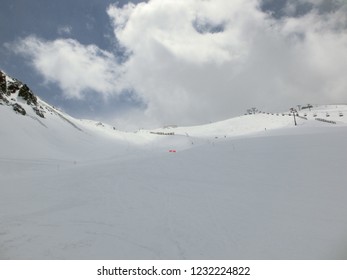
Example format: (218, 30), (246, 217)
(0, 0), (347, 130)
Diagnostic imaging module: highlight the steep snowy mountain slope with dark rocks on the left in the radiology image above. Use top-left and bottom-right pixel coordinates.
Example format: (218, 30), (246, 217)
(0, 71), (159, 158)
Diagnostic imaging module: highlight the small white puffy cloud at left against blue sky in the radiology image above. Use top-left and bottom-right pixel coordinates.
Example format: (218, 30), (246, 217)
(11, 36), (121, 99)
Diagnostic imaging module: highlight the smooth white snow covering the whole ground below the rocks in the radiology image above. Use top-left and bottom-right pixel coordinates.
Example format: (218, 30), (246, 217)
(0, 104), (347, 259)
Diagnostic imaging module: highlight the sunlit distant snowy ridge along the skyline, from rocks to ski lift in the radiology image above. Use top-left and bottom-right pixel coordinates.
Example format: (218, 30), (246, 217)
(0, 70), (347, 143)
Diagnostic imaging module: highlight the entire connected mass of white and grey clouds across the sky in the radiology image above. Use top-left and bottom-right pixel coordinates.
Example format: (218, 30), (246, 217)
(7, 0), (347, 128)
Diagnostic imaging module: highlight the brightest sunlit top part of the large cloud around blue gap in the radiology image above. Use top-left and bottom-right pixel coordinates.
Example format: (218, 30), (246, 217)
(108, 0), (264, 64)
